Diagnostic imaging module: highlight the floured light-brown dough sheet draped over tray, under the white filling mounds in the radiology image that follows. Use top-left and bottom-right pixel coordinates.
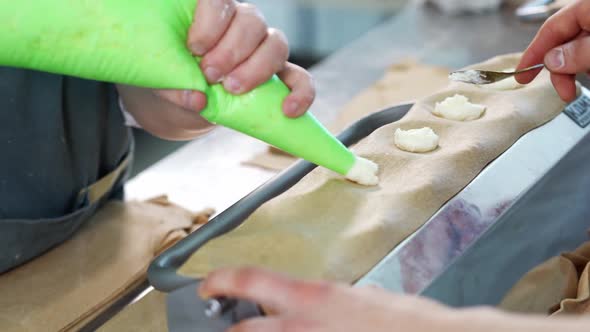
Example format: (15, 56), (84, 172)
(180, 55), (565, 283)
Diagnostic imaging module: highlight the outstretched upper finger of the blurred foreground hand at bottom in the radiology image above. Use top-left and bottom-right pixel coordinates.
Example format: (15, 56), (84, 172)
(199, 268), (327, 314)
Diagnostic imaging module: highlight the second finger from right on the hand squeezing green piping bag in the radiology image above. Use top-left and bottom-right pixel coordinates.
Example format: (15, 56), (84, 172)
(223, 29), (289, 94)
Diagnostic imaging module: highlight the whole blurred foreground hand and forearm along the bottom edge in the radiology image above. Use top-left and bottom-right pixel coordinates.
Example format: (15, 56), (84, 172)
(199, 268), (590, 332)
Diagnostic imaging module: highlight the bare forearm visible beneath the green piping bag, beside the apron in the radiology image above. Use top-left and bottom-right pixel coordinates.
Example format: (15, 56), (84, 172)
(117, 85), (213, 141)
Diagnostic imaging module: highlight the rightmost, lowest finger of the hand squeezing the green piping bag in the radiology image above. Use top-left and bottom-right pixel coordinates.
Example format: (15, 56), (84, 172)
(279, 63), (316, 118)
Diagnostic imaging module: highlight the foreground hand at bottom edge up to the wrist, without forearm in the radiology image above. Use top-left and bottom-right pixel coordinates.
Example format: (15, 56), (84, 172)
(199, 268), (457, 332)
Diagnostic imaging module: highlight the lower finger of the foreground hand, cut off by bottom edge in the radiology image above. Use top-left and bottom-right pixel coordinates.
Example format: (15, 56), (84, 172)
(227, 317), (315, 332)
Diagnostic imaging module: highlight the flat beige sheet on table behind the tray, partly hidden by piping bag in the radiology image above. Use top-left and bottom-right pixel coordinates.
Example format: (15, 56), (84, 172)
(244, 59), (449, 171)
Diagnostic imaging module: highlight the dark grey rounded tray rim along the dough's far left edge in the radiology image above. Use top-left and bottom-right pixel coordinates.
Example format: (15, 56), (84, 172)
(148, 104), (413, 292)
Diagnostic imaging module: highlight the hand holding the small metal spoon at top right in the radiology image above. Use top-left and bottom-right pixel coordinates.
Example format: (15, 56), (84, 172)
(517, 0), (590, 101)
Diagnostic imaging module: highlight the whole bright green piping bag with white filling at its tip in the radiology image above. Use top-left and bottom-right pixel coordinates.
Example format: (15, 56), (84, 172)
(0, 0), (376, 184)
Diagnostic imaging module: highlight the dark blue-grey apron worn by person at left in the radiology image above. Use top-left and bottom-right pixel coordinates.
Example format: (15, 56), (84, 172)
(0, 67), (132, 274)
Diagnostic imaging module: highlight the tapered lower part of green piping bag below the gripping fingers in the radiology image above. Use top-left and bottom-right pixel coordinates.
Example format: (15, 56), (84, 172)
(201, 76), (368, 176)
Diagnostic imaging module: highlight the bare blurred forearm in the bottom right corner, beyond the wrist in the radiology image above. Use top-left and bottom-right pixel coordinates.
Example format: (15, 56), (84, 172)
(449, 309), (590, 332)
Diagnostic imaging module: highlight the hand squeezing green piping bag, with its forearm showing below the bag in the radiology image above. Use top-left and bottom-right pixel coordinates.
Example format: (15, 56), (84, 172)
(117, 0), (315, 140)
